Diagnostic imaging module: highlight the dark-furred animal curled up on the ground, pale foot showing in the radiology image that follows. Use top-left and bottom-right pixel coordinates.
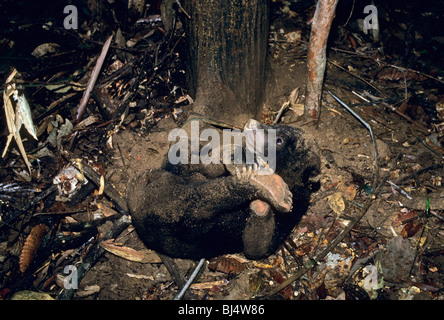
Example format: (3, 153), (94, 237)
(127, 120), (320, 259)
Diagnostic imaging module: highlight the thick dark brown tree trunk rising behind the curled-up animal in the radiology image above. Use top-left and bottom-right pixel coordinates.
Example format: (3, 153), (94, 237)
(184, 0), (269, 125)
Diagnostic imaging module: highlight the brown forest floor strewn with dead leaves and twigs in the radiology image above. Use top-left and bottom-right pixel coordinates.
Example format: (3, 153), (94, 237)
(0, 0), (444, 300)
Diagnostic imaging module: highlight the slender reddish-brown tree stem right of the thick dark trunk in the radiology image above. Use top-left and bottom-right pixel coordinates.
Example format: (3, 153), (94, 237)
(304, 0), (339, 124)
